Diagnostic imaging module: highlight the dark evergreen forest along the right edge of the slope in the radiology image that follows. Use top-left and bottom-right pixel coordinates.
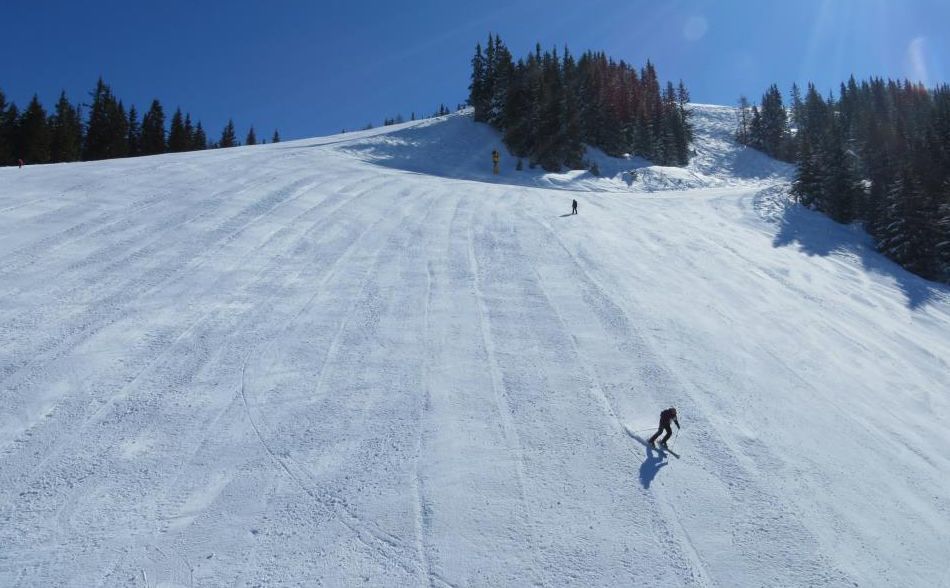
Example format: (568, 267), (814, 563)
(736, 77), (950, 283)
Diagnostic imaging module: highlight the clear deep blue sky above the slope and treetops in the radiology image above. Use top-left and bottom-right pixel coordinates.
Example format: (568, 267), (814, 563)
(0, 0), (950, 138)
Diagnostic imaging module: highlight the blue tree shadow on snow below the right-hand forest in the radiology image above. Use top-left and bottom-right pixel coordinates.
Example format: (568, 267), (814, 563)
(772, 205), (950, 310)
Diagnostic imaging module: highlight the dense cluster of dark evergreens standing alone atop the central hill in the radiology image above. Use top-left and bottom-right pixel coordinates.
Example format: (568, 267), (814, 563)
(469, 35), (693, 171)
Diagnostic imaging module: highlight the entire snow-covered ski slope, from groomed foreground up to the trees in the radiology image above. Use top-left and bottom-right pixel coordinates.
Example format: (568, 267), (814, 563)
(0, 106), (950, 587)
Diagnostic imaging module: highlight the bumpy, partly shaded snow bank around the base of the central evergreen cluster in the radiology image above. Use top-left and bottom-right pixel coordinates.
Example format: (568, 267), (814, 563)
(339, 105), (792, 192)
